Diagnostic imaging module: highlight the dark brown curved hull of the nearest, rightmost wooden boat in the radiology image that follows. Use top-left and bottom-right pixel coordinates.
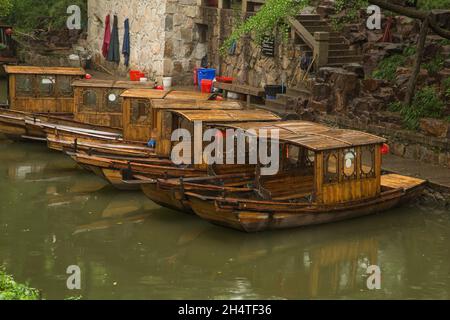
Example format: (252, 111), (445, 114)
(188, 184), (424, 233)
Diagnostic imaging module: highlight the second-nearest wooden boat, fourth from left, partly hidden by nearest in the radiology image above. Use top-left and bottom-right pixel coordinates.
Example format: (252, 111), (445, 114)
(68, 109), (279, 191)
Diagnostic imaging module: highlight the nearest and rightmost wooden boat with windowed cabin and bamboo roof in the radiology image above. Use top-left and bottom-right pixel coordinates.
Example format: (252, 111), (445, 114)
(139, 121), (425, 232)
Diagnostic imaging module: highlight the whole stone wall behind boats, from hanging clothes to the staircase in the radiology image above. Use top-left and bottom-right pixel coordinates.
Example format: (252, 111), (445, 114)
(87, 0), (308, 87)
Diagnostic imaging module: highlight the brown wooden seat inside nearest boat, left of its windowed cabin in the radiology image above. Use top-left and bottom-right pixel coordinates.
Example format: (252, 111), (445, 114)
(261, 172), (314, 200)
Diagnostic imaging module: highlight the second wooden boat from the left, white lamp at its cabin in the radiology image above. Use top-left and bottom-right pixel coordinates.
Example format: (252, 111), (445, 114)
(0, 77), (153, 141)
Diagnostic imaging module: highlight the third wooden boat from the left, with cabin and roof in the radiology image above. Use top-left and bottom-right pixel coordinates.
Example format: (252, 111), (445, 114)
(47, 89), (242, 158)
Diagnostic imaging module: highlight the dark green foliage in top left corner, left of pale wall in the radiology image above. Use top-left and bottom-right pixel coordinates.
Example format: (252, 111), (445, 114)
(0, 0), (87, 32)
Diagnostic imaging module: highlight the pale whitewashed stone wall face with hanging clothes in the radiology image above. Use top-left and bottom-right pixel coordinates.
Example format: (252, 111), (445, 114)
(87, 0), (166, 78)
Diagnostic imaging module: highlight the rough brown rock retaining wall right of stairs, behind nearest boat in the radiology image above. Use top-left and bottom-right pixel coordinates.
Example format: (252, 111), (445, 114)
(308, 65), (450, 167)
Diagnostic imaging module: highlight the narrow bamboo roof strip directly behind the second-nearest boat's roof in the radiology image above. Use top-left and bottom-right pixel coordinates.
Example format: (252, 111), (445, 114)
(152, 100), (243, 110)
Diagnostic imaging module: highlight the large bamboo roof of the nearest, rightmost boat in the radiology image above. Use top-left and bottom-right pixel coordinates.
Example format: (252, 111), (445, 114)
(224, 121), (386, 152)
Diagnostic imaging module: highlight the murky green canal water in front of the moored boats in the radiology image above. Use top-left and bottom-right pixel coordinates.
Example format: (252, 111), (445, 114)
(0, 138), (450, 299)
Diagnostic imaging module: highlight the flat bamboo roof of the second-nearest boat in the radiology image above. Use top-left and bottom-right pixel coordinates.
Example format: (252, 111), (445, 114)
(171, 110), (280, 123)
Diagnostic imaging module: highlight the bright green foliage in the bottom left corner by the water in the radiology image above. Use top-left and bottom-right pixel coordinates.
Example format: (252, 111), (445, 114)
(0, 269), (40, 300)
